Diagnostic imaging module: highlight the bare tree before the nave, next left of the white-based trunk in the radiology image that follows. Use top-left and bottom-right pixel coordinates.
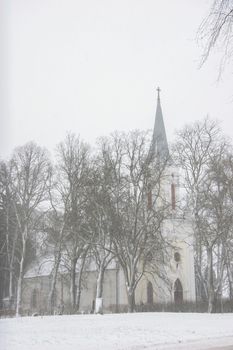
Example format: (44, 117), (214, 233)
(57, 134), (89, 311)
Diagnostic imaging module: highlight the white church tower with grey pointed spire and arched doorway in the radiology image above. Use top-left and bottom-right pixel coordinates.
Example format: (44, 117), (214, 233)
(144, 88), (196, 304)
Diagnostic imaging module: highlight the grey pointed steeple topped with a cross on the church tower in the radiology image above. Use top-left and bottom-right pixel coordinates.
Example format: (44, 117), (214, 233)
(150, 87), (169, 158)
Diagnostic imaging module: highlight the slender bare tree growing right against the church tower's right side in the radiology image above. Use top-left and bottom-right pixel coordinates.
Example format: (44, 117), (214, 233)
(173, 118), (219, 304)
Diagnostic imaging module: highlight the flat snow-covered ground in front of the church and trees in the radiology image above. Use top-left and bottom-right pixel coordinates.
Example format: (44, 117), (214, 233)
(0, 313), (233, 350)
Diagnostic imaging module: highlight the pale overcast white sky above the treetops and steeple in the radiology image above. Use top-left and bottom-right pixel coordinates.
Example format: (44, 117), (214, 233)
(0, 0), (233, 158)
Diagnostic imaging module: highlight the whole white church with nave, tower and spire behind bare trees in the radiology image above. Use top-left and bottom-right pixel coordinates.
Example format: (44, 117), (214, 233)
(22, 88), (196, 314)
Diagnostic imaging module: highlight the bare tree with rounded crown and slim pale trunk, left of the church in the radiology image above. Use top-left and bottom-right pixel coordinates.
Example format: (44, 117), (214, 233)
(10, 142), (50, 316)
